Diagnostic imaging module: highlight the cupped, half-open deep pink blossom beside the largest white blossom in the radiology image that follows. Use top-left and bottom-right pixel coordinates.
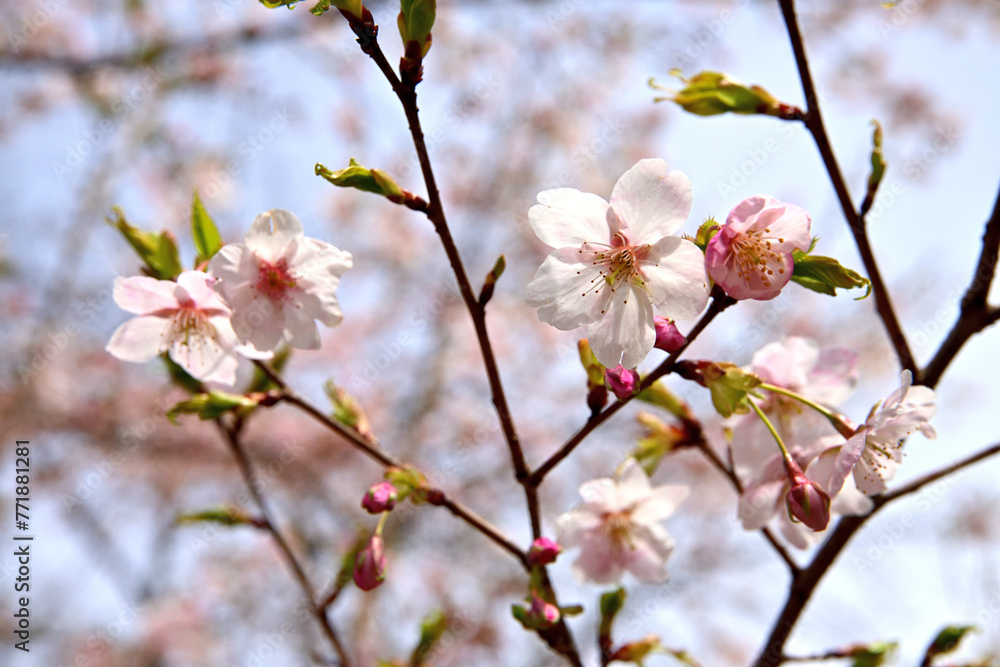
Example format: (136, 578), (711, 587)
(705, 195), (812, 301)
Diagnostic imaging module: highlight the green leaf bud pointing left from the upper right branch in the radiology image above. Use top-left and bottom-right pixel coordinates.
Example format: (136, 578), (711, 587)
(649, 69), (791, 117)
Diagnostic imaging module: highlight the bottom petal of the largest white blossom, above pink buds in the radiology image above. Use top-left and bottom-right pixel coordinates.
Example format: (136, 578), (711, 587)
(584, 285), (656, 368)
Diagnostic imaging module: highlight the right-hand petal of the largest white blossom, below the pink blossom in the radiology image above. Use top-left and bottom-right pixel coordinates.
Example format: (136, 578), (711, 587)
(642, 236), (708, 320)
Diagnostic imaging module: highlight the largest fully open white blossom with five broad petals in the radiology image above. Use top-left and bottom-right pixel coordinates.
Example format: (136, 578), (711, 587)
(527, 159), (708, 368)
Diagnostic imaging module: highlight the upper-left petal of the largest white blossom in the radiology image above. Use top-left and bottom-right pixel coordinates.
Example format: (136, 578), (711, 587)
(528, 188), (611, 248)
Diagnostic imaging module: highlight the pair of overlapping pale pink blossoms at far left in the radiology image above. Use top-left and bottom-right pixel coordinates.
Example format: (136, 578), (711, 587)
(107, 209), (351, 386)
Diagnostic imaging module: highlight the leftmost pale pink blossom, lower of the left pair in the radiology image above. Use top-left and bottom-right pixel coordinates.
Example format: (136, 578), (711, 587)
(106, 271), (270, 386)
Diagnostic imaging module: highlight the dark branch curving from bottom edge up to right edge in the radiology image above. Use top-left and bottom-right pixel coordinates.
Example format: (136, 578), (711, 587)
(753, 442), (1000, 667)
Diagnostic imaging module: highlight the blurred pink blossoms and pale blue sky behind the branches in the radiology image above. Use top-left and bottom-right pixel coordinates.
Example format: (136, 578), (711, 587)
(0, 0), (1000, 667)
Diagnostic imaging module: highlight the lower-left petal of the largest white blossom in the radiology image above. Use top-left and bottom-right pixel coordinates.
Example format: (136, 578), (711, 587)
(527, 248), (608, 332)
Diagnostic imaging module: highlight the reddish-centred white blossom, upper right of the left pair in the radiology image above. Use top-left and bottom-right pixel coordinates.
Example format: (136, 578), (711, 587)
(209, 209), (352, 350)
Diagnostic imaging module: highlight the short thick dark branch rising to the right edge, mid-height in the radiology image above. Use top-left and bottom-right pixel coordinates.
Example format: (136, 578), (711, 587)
(914, 185), (1000, 387)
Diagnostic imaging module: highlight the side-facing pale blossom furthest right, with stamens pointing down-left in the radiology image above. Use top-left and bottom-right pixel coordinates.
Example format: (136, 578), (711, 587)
(837, 370), (937, 495)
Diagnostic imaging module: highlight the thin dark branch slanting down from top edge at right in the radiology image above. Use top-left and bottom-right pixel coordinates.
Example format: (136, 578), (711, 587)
(778, 0), (918, 377)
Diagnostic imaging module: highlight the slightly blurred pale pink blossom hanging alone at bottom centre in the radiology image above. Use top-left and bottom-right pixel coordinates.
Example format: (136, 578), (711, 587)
(556, 458), (688, 584)
